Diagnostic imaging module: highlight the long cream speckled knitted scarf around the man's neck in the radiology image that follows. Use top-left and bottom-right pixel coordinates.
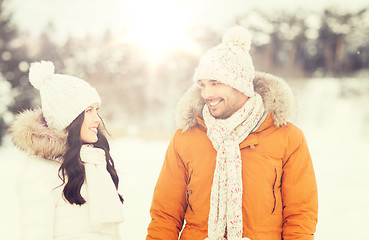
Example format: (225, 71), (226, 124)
(203, 93), (264, 240)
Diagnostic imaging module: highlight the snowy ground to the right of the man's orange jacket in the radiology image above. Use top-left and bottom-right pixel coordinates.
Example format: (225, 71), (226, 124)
(296, 79), (369, 239)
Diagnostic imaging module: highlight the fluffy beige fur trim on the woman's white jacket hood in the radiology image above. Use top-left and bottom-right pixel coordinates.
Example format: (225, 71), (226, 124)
(10, 109), (67, 160)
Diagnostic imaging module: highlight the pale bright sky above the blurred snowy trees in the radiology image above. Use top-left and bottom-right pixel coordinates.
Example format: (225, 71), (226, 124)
(5, 0), (369, 59)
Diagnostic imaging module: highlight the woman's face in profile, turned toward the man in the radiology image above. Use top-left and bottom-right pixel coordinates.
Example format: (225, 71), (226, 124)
(81, 103), (101, 143)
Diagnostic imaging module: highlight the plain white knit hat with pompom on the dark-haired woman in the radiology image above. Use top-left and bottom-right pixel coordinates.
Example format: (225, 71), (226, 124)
(29, 61), (101, 130)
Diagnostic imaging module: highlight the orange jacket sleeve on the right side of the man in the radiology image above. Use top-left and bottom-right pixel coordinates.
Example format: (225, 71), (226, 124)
(282, 128), (318, 240)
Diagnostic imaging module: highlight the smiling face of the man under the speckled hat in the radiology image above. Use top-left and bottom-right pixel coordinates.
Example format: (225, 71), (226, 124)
(198, 79), (248, 119)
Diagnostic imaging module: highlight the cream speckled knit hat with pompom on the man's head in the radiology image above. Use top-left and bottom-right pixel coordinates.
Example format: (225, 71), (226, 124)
(193, 26), (255, 97)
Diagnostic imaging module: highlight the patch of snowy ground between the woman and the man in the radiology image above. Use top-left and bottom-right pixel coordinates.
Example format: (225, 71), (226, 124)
(111, 138), (169, 240)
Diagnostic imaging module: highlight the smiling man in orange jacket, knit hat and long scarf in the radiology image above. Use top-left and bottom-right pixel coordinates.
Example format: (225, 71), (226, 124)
(146, 27), (318, 240)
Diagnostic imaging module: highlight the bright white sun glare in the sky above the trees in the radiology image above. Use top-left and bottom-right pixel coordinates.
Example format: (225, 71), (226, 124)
(119, 0), (196, 61)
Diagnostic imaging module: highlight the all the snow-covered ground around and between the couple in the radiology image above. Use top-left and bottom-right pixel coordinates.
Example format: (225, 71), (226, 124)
(0, 79), (369, 240)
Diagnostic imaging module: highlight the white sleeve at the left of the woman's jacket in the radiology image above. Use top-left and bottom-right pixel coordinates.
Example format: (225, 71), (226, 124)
(18, 158), (58, 240)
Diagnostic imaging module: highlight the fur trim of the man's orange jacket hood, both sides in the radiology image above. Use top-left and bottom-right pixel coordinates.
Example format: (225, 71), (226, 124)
(175, 72), (296, 132)
